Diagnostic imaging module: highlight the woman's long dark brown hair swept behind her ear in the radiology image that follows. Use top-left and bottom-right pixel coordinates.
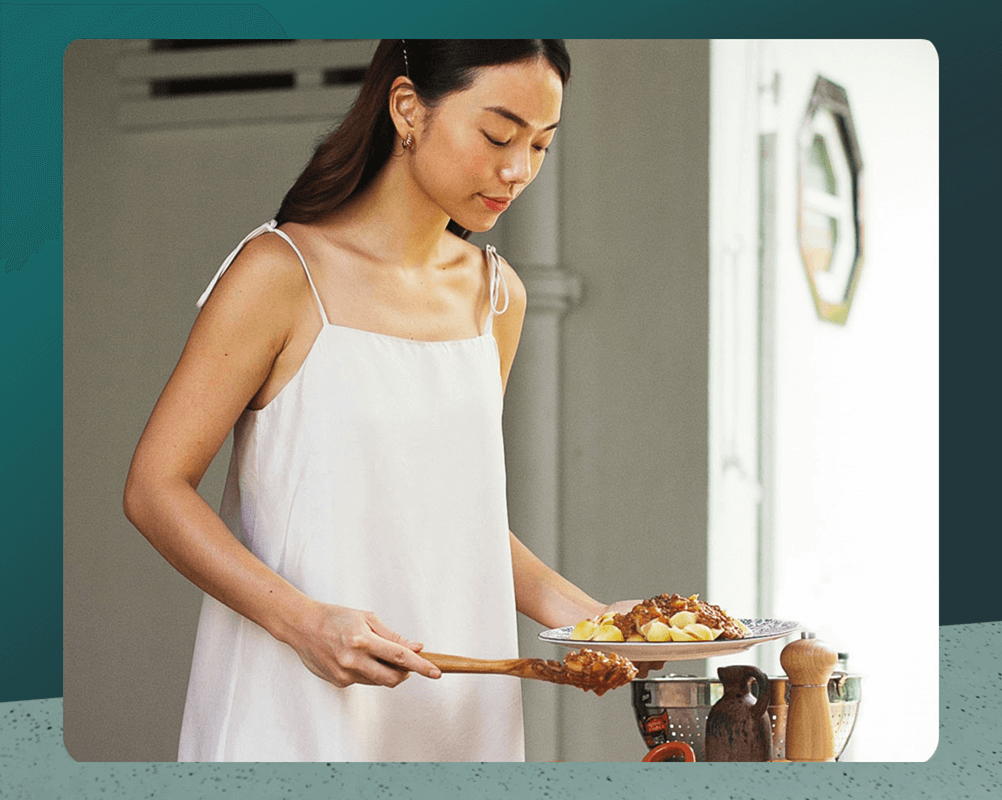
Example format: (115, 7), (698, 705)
(276, 39), (570, 238)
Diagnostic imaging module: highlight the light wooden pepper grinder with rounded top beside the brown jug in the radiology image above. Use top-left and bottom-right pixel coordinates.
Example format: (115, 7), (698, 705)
(780, 633), (839, 761)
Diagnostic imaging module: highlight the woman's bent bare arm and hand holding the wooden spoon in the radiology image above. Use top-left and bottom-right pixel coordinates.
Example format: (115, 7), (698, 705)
(124, 236), (438, 686)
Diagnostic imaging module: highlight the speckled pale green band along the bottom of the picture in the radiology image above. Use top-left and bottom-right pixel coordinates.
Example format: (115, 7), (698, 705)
(0, 623), (1002, 800)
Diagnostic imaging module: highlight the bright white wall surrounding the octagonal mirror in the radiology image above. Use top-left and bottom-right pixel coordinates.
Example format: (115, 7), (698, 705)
(710, 40), (939, 761)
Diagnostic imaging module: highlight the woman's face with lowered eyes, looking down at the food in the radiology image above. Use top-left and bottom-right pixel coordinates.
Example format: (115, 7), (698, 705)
(411, 57), (563, 232)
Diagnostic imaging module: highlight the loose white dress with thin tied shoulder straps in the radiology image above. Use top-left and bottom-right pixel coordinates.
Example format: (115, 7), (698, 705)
(178, 221), (525, 762)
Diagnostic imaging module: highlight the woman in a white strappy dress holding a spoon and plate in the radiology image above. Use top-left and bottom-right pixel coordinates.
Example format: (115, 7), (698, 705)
(125, 40), (649, 761)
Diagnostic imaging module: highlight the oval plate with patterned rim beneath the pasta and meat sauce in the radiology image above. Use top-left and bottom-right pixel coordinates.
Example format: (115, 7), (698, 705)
(539, 620), (801, 662)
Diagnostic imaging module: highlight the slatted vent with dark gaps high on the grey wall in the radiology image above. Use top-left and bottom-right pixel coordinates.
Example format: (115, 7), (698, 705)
(118, 39), (377, 129)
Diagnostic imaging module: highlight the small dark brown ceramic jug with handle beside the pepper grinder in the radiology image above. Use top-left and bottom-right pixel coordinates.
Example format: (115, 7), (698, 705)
(705, 666), (773, 761)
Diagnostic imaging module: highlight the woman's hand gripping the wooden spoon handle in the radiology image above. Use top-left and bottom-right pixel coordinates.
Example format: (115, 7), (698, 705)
(287, 604), (442, 689)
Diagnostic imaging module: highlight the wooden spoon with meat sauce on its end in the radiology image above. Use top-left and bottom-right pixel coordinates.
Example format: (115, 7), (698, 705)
(420, 649), (636, 697)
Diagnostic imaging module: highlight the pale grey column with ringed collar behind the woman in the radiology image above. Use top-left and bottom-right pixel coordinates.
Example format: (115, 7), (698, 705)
(502, 148), (581, 761)
